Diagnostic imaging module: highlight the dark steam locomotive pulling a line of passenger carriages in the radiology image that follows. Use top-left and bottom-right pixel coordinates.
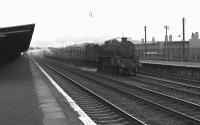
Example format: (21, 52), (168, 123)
(46, 37), (141, 75)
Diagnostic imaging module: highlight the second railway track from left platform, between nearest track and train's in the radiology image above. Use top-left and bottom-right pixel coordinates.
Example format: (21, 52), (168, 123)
(39, 57), (200, 124)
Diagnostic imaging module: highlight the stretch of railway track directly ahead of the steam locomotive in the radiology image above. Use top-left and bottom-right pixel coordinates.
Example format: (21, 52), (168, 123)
(99, 72), (200, 105)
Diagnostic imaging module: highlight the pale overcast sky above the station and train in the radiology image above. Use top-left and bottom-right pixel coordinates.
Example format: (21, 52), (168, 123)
(0, 0), (200, 47)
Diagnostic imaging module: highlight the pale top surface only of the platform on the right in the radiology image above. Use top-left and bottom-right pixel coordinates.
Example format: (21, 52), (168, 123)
(140, 60), (200, 68)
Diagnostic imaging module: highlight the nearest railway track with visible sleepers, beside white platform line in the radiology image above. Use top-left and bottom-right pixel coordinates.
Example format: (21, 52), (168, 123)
(37, 57), (146, 125)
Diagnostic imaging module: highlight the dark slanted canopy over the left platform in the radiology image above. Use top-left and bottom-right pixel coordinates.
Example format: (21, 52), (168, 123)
(0, 24), (35, 53)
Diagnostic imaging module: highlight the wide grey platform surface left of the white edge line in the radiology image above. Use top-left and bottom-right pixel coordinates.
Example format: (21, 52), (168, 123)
(0, 56), (89, 125)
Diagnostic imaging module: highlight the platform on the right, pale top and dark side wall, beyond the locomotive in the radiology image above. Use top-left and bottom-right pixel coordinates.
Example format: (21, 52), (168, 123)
(140, 60), (200, 81)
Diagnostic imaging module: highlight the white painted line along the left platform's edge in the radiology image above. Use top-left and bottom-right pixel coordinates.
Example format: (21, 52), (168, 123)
(33, 59), (96, 125)
